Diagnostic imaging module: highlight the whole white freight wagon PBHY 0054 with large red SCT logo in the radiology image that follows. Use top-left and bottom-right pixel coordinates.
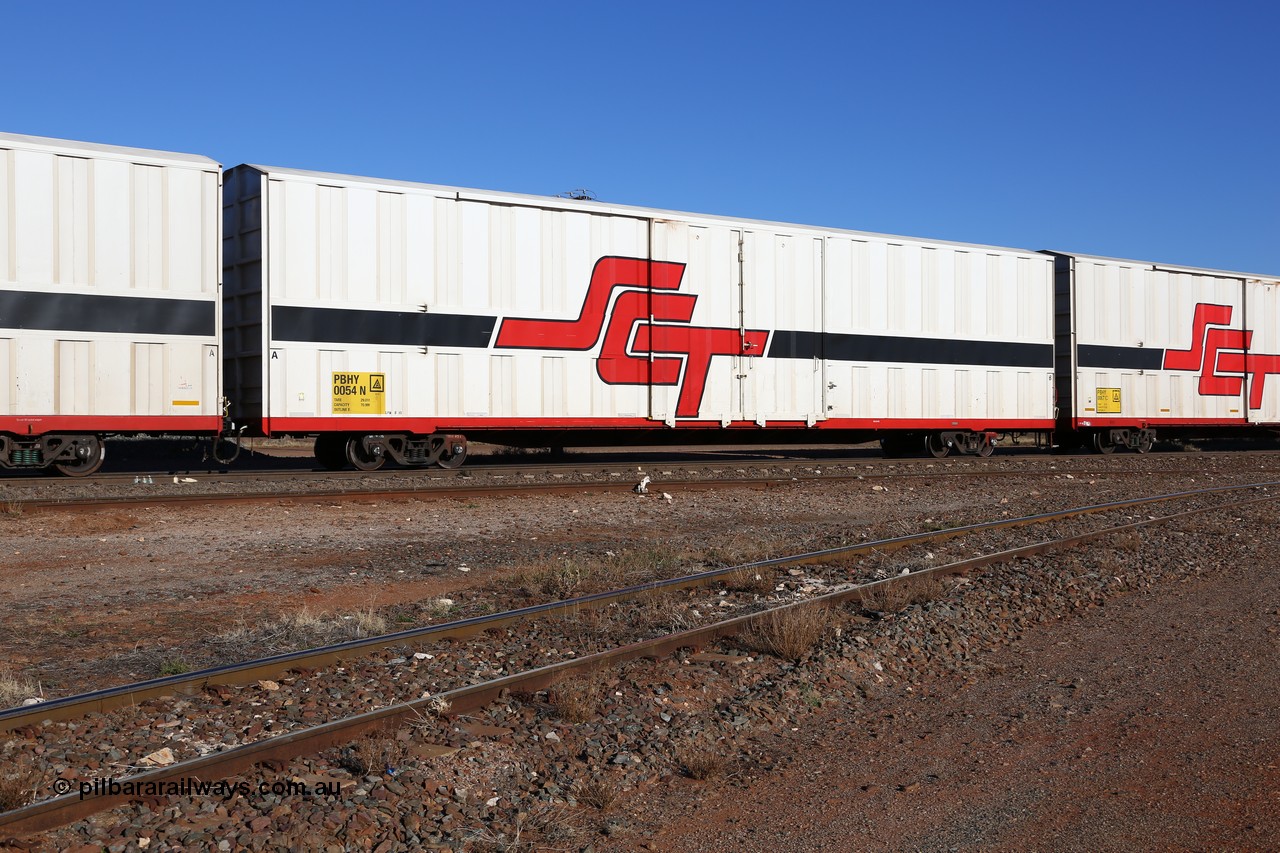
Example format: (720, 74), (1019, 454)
(224, 159), (1055, 469)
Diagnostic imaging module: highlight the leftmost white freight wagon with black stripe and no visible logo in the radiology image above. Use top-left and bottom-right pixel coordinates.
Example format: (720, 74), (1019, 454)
(0, 133), (223, 475)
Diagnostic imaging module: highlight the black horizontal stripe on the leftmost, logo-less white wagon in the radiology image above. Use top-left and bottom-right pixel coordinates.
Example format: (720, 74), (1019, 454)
(0, 291), (218, 337)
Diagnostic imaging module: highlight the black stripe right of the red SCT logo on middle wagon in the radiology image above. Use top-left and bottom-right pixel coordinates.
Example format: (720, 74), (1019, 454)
(768, 332), (1053, 369)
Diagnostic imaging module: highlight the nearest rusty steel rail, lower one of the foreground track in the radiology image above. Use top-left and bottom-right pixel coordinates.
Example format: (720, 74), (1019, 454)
(0, 484), (1280, 835)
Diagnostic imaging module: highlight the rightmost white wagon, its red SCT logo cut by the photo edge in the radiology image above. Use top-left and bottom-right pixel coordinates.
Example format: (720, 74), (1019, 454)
(1055, 252), (1280, 452)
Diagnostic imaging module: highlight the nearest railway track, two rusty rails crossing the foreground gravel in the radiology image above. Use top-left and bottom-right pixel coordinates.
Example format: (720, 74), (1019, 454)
(0, 483), (1277, 833)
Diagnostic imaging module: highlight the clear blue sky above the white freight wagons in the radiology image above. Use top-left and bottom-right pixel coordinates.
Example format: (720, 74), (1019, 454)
(10, 0), (1280, 274)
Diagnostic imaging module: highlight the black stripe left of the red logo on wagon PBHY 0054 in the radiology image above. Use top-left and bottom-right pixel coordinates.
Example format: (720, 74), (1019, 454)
(271, 305), (498, 347)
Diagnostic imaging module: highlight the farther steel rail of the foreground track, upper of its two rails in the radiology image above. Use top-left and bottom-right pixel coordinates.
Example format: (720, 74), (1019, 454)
(0, 480), (1280, 731)
